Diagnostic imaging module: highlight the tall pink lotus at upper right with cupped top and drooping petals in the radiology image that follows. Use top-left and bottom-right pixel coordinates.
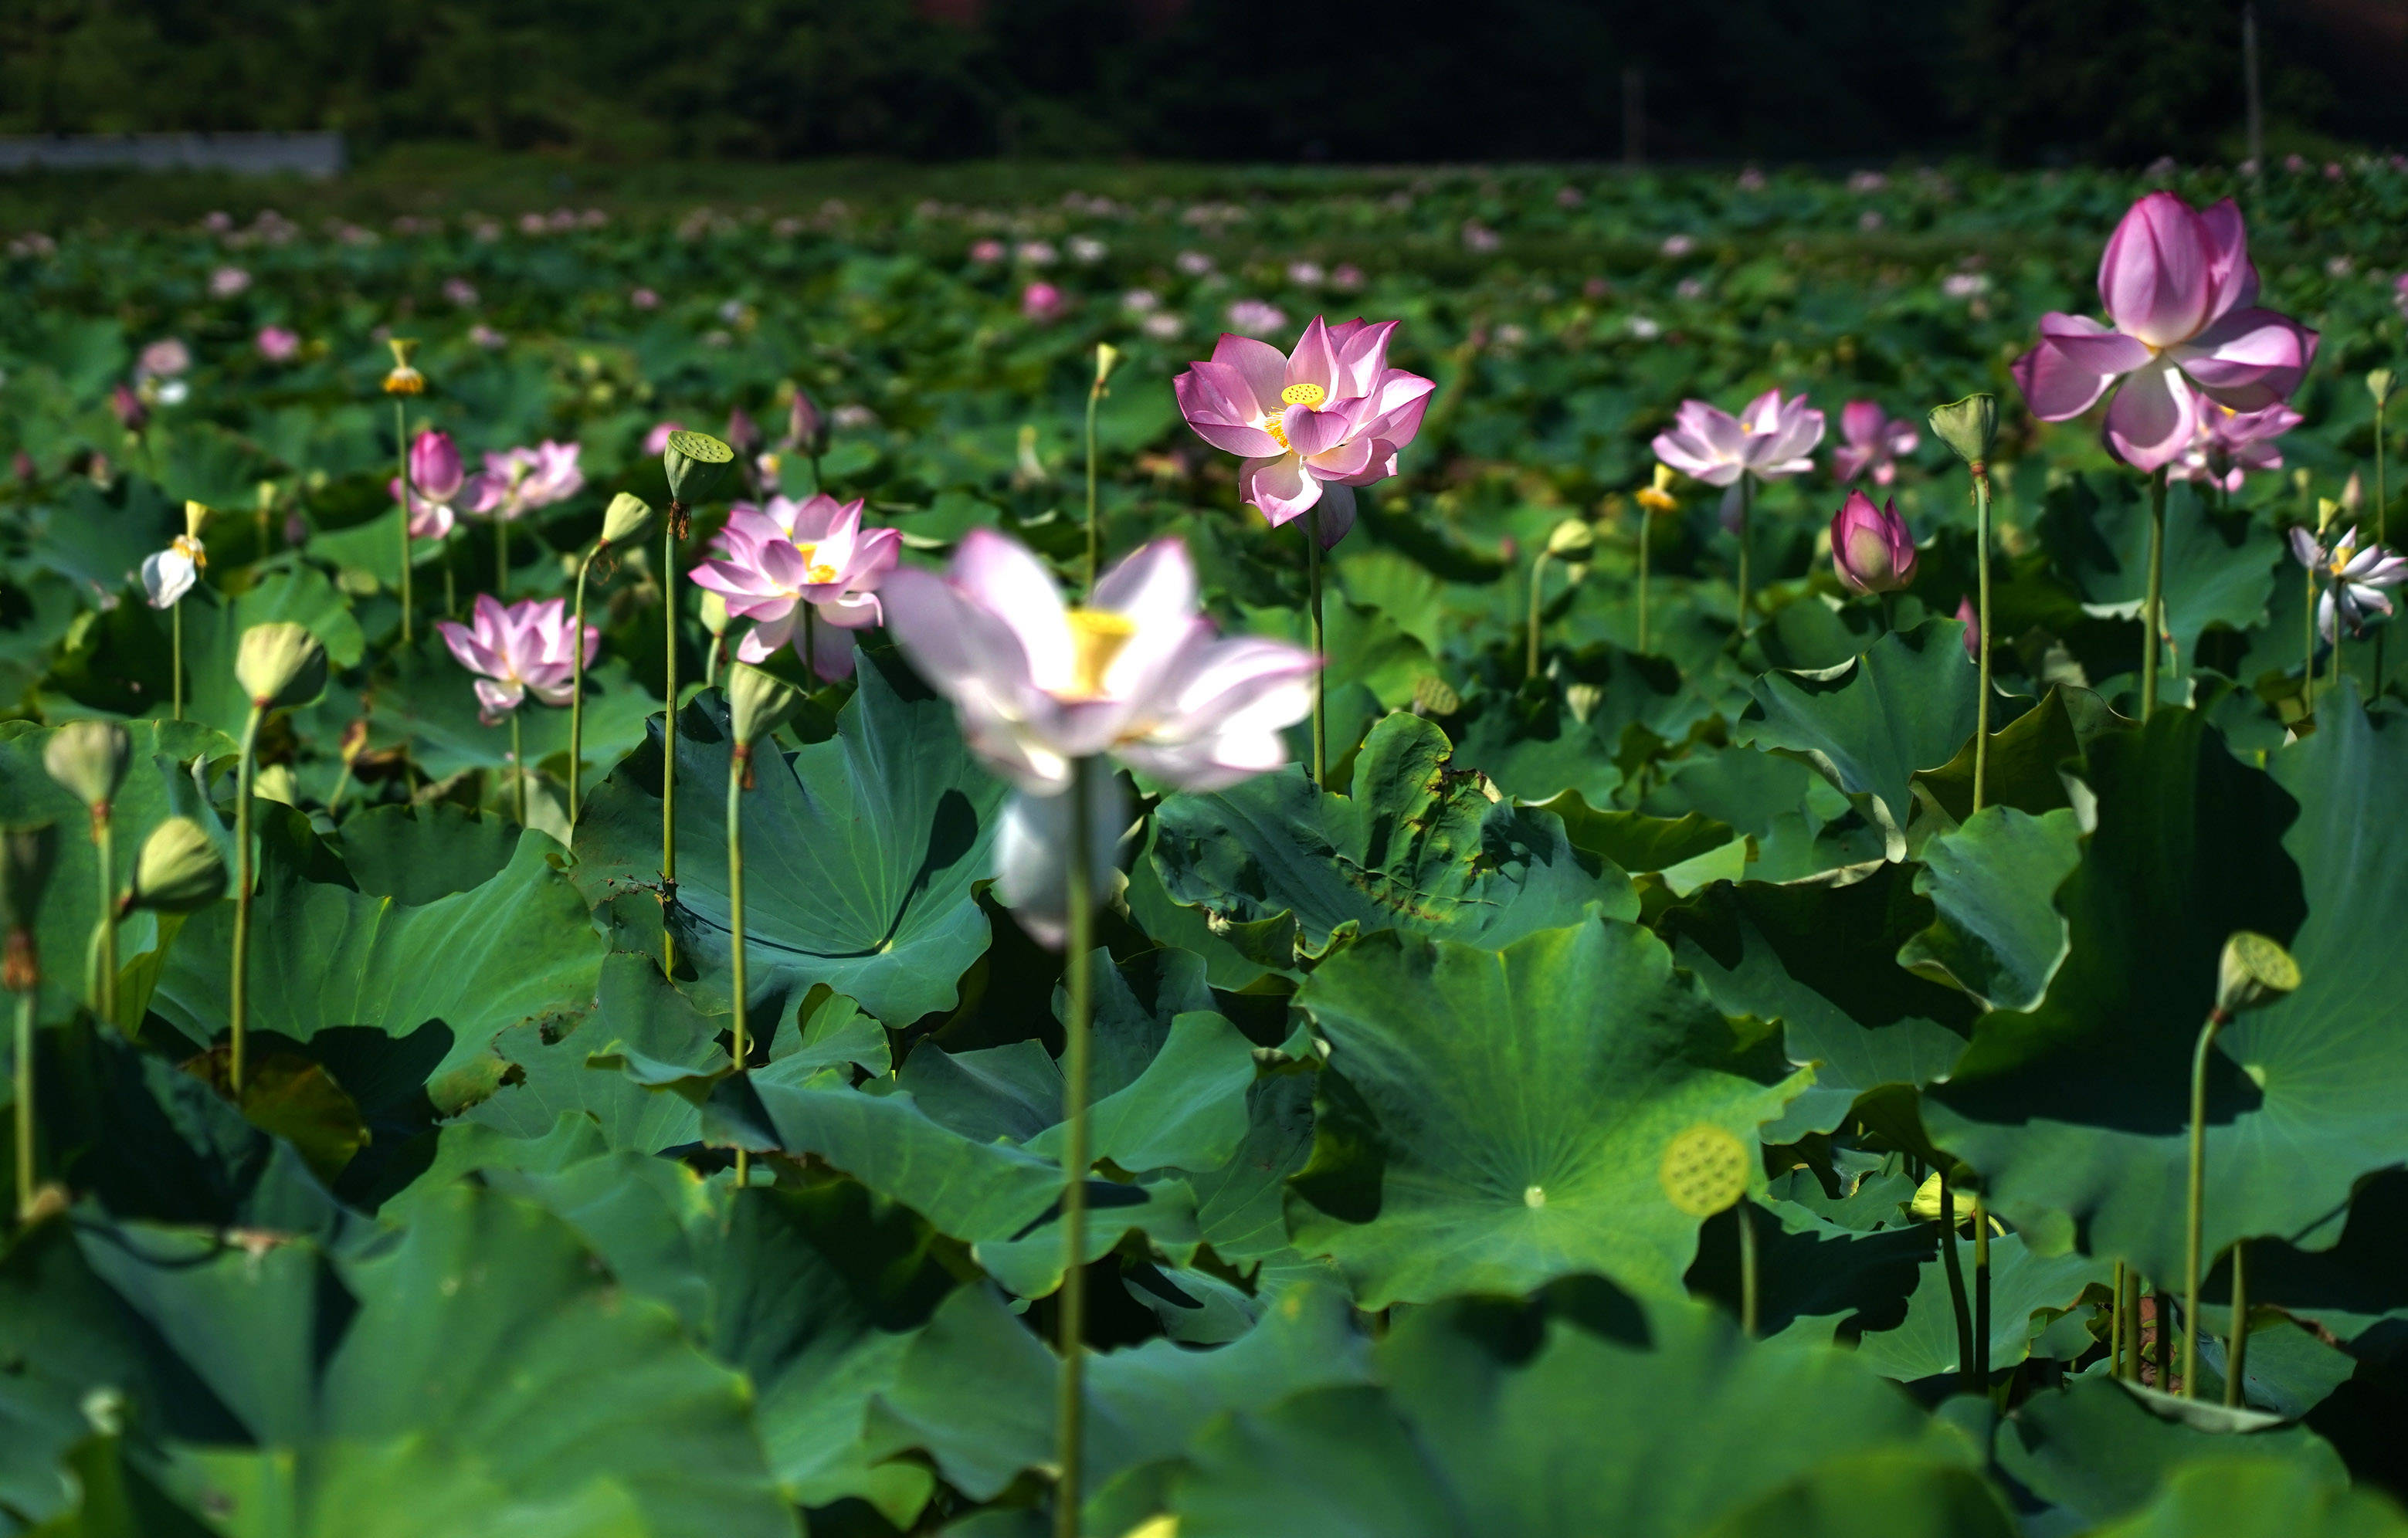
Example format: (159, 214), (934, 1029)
(2016, 192), (2317, 469)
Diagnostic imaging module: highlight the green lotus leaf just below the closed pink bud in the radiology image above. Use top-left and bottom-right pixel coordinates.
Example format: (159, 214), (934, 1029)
(1734, 618), (1979, 855)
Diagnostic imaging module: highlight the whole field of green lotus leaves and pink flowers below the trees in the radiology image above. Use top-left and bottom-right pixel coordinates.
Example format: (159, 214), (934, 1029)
(0, 157), (2408, 1538)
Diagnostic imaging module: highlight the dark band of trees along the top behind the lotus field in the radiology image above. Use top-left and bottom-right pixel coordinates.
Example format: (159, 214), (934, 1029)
(0, 0), (2408, 164)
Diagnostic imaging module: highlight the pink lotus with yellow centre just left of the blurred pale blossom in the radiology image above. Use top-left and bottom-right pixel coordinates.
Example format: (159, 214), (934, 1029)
(691, 493), (903, 679)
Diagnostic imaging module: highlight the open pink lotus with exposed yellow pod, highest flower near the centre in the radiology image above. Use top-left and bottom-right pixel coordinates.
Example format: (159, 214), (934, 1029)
(1172, 315), (1437, 549)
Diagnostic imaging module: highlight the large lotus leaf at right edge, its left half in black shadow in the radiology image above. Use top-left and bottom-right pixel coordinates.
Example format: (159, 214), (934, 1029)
(1924, 703), (2408, 1278)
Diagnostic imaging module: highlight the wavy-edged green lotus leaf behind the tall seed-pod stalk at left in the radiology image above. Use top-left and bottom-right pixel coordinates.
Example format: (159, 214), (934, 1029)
(151, 833), (605, 1073)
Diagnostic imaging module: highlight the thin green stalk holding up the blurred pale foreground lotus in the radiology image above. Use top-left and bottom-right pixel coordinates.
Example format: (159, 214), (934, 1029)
(1055, 761), (1097, 1538)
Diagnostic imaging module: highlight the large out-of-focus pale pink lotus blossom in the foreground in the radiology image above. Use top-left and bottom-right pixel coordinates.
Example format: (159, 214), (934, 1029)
(879, 530), (1320, 797)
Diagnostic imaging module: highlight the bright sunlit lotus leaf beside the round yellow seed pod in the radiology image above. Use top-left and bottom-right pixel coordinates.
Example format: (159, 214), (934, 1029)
(1288, 920), (1811, 1309)
